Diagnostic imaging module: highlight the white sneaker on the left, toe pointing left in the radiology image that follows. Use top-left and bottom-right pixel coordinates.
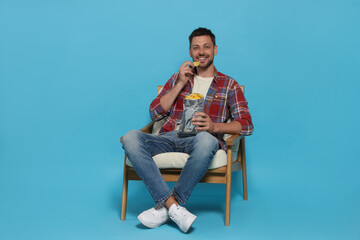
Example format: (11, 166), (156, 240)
(138, 205), (170, 228)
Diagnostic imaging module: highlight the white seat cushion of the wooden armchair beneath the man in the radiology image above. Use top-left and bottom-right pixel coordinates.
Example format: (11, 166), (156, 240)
(126, 149), (226, 169)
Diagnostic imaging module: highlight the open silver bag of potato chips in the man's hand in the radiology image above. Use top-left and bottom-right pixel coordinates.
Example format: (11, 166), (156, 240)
(178, 93), (204, 137)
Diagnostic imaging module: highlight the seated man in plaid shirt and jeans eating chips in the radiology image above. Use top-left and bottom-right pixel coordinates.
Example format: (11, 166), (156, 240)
(123, 28), (253, 233)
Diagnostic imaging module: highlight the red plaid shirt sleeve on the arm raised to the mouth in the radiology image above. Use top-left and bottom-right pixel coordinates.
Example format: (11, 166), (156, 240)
(149, 73), (179, 121)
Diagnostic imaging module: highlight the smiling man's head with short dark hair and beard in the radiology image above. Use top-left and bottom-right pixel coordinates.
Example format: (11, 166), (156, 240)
(189, 28), (217, 69)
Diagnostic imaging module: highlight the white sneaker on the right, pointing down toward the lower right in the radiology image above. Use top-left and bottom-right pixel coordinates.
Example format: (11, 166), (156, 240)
(169, 203), (196, 233)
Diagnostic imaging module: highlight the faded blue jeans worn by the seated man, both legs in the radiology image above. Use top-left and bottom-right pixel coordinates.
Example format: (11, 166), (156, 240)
(122, 130), (219, 204)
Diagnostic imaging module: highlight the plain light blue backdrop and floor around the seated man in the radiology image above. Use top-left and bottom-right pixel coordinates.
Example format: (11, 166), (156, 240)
(0, 0), (360, 240)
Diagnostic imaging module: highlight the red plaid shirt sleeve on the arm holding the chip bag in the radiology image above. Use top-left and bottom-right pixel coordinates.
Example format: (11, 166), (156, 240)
(228, 80), (254, 135)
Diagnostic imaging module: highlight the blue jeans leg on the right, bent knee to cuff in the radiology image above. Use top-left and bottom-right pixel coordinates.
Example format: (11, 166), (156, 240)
(173, 132), (219, 204)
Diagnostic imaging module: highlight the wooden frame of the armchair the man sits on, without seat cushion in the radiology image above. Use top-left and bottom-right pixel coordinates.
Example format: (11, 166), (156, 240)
(120, 86), (247, 226)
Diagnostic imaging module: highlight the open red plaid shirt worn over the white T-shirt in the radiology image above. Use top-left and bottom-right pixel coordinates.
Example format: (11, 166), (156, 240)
(149, 69), (254, 150)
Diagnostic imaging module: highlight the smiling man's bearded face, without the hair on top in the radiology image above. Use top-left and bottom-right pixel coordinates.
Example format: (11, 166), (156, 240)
(189, 36), (217, 69)
